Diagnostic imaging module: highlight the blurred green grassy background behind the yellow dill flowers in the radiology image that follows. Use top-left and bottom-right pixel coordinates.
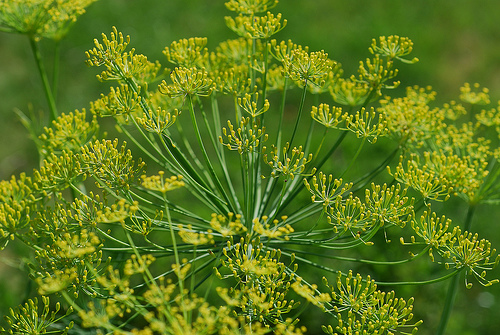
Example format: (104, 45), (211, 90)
(0, 0), (500, 335)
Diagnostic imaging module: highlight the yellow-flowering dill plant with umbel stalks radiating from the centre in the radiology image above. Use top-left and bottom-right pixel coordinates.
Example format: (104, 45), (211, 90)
(0, 0), (500, 334)
